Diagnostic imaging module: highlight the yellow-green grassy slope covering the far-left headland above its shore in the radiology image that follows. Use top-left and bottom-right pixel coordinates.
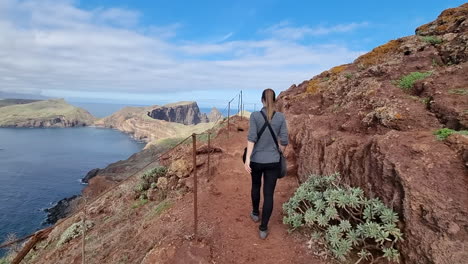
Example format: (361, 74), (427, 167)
(0, 99), (94, 126)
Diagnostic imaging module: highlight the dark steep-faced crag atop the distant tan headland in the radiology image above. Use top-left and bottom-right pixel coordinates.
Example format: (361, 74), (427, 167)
(148, 102), (209, 125)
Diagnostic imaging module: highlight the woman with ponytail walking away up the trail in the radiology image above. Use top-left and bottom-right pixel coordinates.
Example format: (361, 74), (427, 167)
(245, 89), (288, 239)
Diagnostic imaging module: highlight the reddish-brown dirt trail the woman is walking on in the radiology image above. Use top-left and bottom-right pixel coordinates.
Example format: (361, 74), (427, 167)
(144, 120), (324, 264)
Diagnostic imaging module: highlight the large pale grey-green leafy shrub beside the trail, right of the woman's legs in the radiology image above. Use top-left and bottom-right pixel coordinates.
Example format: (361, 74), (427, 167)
(283, 174), (403, 262)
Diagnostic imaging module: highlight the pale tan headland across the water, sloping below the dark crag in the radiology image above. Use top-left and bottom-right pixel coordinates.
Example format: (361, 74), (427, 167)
(95, 103), (211, 142)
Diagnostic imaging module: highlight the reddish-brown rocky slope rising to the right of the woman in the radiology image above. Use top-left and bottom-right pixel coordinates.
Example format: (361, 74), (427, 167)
(279, 4), (468, 264)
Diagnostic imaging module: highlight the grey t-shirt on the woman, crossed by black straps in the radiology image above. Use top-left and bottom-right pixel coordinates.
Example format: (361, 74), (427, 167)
(247, 107), (288, 163)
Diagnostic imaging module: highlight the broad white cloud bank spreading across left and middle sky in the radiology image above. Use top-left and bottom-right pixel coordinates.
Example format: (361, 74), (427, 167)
(0, 0), (362, 103)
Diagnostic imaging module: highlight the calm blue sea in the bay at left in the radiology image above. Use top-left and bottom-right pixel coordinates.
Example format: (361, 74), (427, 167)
(0, 127), (144, 256)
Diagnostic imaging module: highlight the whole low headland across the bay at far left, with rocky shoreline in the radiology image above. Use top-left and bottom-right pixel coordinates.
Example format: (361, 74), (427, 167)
(0, 99), (95, 127)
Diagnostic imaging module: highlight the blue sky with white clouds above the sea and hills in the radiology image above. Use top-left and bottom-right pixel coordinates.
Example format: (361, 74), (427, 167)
(0, 0), (464, 107)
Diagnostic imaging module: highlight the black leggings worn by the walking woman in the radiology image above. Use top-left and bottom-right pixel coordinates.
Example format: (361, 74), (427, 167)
(250, 162), (281, 231)
